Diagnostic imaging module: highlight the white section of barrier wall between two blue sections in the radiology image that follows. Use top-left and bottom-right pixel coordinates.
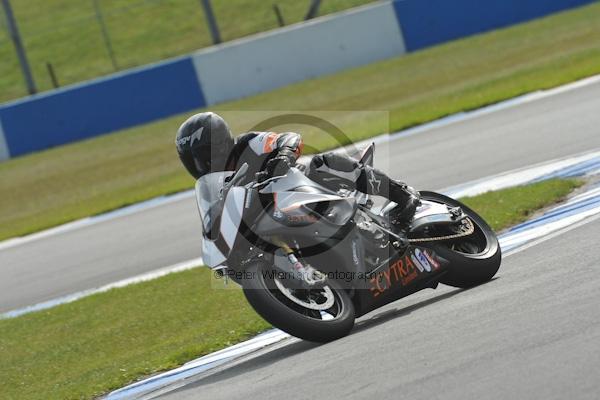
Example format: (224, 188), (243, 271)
(192, 2), (406, 105)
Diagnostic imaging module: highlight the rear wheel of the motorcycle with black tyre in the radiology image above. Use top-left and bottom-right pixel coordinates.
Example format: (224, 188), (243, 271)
(412, 192), (502, 288)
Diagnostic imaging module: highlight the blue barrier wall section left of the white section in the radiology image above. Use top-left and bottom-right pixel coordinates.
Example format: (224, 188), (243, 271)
(0, 58), (206, 157)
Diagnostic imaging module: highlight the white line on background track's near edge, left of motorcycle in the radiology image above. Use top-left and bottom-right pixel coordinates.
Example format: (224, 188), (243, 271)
(0, 257), (204, 319)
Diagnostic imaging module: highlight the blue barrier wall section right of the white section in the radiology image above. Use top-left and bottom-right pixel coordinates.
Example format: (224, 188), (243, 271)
(394, 0), (595, 51)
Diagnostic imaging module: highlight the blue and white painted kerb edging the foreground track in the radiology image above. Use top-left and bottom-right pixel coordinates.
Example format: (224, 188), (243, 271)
(106, 184), (600, 400)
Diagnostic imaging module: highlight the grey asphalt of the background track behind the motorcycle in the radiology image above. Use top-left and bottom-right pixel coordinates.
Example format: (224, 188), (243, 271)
(0, 78), (600, 312)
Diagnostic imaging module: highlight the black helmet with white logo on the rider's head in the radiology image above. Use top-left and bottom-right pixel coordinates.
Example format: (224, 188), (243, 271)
(175, 112), (233, 179)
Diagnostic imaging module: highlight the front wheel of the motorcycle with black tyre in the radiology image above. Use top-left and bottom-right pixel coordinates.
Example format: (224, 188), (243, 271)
(242, 262), (355, 342)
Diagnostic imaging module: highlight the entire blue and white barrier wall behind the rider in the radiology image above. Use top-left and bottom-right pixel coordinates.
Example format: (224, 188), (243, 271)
(0, 0), (597, 161)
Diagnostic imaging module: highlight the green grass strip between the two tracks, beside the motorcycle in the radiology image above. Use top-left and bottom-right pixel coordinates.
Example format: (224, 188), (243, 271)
(0, 180), (581, 400)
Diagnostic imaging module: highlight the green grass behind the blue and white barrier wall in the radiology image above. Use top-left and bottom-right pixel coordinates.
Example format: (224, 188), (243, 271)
(0, 0), (373, 102)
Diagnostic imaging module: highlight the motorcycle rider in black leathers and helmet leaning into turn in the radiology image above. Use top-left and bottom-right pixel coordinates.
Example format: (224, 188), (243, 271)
(175, 112), (419, 233)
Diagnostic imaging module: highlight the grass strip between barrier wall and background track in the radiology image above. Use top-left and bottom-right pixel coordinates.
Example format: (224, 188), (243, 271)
(0, 3), (600, 239)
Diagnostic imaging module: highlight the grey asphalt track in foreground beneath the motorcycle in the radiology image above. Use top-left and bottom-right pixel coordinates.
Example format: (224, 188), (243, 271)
(159, 219), (600, 400)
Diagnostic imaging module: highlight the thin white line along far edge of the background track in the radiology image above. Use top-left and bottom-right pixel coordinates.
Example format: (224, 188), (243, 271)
(0, 75), (600, 250)
